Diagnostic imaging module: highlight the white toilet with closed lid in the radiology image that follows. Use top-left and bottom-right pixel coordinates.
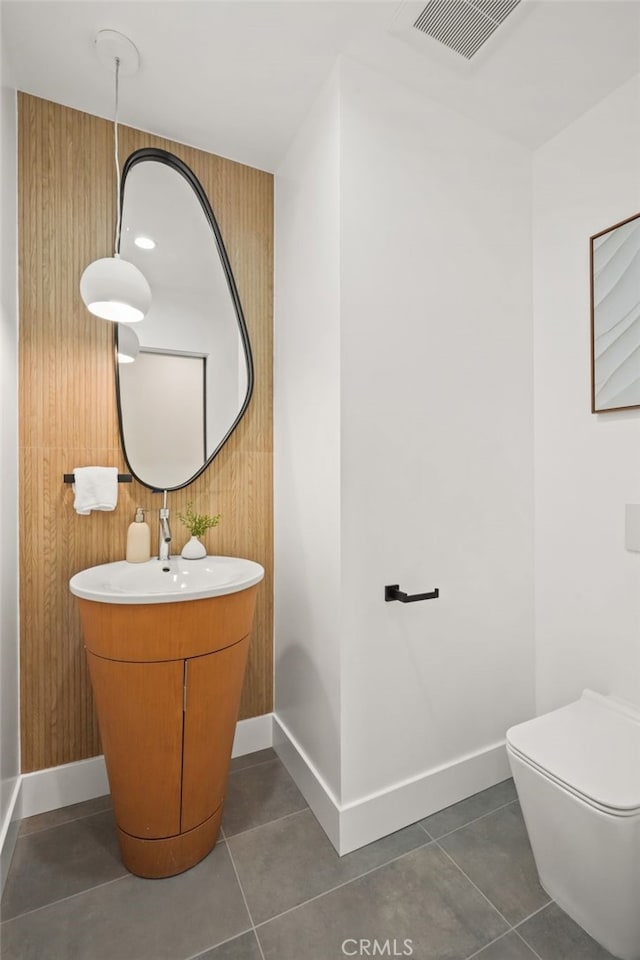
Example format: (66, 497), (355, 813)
(507, 690), (640, 960)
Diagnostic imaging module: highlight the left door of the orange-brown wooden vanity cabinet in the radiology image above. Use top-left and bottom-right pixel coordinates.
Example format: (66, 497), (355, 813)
(87, 651), (184, 840)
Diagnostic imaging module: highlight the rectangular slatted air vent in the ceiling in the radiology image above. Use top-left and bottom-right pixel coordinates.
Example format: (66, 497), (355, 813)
(414, 0), (520, 60)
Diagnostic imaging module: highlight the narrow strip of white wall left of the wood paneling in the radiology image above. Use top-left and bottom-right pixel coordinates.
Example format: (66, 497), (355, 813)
(0, 65), (20, 888)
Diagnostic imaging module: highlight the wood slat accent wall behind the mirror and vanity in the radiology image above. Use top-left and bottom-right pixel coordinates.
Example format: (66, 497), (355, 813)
(18, 94), (273, 773)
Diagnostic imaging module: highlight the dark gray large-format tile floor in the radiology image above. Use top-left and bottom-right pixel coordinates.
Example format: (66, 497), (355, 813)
(0, 750), (612, 960)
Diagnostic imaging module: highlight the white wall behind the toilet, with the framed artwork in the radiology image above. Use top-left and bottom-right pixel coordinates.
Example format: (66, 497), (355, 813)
(533, 76), (640, 713)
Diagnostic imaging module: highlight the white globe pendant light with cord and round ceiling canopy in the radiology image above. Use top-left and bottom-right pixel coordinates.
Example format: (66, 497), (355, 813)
(80, 30), (151, 323)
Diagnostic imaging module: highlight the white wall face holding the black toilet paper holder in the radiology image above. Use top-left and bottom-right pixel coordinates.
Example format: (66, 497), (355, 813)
(341, 60), (534, 802)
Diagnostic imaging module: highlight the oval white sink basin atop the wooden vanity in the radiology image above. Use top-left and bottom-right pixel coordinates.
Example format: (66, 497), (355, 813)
(69, 556), (264, 603)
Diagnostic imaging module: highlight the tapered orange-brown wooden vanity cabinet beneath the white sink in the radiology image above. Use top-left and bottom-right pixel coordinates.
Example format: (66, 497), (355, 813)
(79, 587), (257, 877)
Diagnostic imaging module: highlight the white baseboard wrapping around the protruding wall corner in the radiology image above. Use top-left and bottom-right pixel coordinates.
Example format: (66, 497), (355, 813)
(273, 715), (511, 856)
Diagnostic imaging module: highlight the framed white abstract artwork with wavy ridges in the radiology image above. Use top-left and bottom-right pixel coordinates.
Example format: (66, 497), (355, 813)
(591, 213), (640, 413)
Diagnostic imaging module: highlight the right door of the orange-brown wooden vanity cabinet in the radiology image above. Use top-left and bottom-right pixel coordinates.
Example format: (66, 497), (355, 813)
(181, 637), (249, 831)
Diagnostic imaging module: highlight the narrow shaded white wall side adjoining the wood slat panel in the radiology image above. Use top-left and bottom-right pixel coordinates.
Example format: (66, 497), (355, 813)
(274, 75), (341, 794)
